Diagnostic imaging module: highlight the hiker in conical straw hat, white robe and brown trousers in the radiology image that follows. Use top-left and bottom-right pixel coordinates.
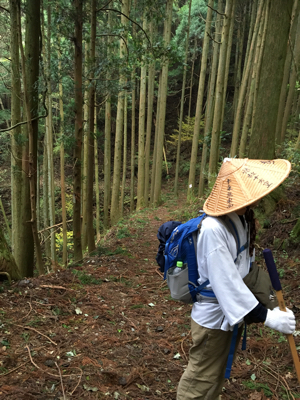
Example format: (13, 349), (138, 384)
(177, 159), (296, 400)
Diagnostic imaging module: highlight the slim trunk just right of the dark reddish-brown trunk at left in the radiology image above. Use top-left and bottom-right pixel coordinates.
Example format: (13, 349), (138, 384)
(86, 0), (97, 253)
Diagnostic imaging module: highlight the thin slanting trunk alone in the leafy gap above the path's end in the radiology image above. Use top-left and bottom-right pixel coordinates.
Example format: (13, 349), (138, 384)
(174, 0), (192, 196)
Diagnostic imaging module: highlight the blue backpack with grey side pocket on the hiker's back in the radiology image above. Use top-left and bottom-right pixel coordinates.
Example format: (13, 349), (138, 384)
(156, 213), (247, 303)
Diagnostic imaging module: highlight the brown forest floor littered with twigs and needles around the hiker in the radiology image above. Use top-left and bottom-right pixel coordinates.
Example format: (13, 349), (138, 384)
(0, 180), (300, 400)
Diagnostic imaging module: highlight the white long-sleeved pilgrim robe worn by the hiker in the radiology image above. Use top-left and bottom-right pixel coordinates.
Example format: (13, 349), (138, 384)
(191, 212), (258, 331)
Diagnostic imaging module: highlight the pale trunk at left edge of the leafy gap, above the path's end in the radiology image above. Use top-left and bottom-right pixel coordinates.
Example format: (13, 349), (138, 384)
(153, 0), (173, 206)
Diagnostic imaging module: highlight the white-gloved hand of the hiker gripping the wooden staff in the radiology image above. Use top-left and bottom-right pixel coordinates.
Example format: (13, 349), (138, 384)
(265, 307), (296, 335)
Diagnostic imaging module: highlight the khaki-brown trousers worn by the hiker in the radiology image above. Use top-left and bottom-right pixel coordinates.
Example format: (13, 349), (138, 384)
(176, 319), (243, 400)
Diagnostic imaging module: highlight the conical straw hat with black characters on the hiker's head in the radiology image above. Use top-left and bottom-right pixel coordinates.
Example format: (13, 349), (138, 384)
(203, 158), (291, 216)
